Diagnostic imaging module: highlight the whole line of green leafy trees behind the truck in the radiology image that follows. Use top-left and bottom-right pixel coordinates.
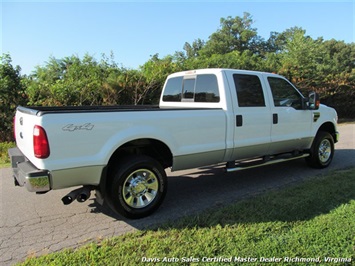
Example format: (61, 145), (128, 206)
(0, 13), (355, 141)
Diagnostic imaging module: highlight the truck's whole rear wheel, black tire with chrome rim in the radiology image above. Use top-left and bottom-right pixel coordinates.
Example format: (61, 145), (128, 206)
(107, 155), (167, 219)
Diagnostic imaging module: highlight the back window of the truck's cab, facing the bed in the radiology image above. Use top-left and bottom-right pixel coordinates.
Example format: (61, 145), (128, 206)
(163, 74), (220, 102)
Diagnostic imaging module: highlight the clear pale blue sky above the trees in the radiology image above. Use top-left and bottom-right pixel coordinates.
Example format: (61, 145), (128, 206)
(0, 0), (355, 74)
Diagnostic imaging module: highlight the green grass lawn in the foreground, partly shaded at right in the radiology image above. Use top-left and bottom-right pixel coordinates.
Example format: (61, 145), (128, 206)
(18, 168), (355, 265)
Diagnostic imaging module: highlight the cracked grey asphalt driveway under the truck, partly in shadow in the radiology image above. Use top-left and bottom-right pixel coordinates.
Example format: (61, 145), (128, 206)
(0, 124), (355, 265)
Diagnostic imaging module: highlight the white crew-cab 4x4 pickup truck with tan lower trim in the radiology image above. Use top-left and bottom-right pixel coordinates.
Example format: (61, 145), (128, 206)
(9, 69), (338, 218)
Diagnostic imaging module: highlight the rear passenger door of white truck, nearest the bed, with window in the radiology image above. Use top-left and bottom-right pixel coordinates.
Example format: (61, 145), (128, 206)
(227, 72), (272, 160)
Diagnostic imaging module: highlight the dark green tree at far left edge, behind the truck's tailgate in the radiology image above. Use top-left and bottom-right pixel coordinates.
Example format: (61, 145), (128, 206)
(0, 54), (26, 142)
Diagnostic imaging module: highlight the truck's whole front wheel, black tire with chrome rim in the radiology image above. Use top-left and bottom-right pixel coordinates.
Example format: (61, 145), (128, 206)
(306, 131), (334, 168)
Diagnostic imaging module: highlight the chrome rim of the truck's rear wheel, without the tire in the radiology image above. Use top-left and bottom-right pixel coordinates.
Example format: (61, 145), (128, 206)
(122, 169), (159, 209)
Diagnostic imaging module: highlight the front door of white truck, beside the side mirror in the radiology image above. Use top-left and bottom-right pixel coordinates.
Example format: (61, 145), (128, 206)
(265, 76), (312, 154)
